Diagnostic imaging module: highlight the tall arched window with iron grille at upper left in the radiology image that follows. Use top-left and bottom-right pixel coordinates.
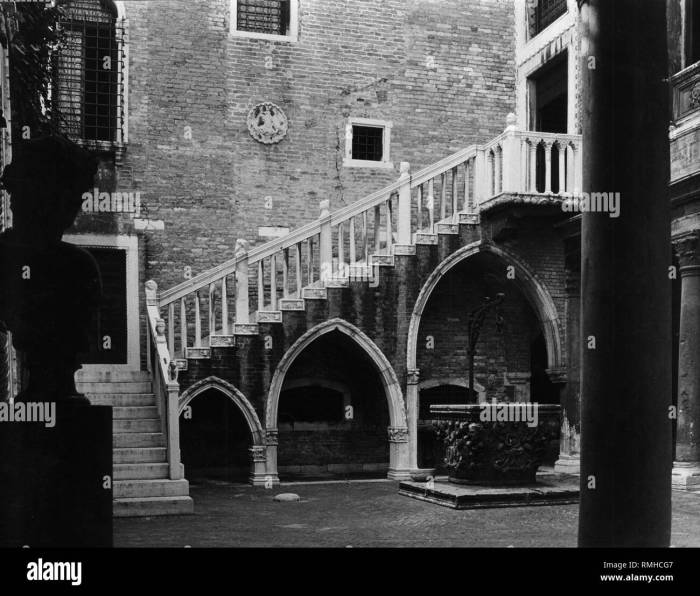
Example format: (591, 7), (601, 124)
(54, 0), (126, 149)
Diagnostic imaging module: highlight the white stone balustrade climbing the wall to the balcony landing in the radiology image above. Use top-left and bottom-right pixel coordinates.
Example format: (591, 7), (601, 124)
(157, 114), (581, 358)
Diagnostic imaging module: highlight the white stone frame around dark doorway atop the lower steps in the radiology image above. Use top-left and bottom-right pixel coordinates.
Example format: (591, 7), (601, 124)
(63, 234), (141, 378)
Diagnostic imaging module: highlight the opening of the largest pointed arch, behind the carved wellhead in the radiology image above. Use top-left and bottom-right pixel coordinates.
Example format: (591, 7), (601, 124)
(409, 246), (560, 467)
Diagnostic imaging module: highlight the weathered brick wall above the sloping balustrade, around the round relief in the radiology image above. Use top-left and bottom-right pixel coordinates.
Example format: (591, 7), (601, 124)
(120, 0), (514, 288)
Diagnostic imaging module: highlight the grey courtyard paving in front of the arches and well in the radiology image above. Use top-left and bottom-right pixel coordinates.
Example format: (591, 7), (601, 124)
(114, 481), (700, 548)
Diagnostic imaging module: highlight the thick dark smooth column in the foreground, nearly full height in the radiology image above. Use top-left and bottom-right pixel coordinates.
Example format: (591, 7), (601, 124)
(579, 0), (671, 546)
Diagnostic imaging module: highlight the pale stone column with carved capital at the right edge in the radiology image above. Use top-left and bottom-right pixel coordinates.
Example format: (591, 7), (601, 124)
(672, 231), (700, 489)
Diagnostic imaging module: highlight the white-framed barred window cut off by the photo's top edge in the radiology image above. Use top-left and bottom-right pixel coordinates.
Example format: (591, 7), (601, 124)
(231, 0), (298, 41)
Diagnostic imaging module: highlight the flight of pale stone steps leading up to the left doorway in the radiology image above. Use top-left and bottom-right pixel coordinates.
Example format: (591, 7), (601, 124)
(77, 371), (193, 517)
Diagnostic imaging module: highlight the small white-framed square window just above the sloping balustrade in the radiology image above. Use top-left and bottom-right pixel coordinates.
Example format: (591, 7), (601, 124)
(343, 118), (394, 168)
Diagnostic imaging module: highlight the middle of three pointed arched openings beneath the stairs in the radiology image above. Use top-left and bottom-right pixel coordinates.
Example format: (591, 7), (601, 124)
(277, 330), (389, 480)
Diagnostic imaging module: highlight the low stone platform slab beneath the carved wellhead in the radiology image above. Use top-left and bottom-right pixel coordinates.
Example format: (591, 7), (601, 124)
(399, 474), (579, 509)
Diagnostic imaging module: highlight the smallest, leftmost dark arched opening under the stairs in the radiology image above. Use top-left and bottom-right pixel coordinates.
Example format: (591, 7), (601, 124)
(180, 388), (252, 483)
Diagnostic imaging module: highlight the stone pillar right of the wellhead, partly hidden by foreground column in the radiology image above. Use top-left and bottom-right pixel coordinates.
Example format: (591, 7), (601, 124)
(554, 235), (581, 474)
